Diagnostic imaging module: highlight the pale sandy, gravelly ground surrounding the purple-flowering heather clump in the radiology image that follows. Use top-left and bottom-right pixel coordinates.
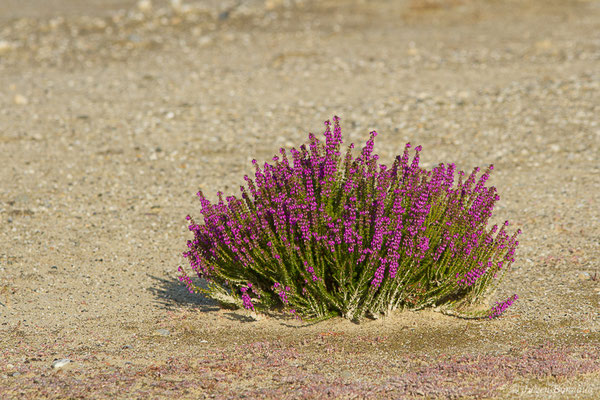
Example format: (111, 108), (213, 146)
(0, 0), (600, 399)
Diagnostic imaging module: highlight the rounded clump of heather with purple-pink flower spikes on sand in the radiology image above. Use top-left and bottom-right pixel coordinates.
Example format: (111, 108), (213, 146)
(179, 117), (520, 320)
